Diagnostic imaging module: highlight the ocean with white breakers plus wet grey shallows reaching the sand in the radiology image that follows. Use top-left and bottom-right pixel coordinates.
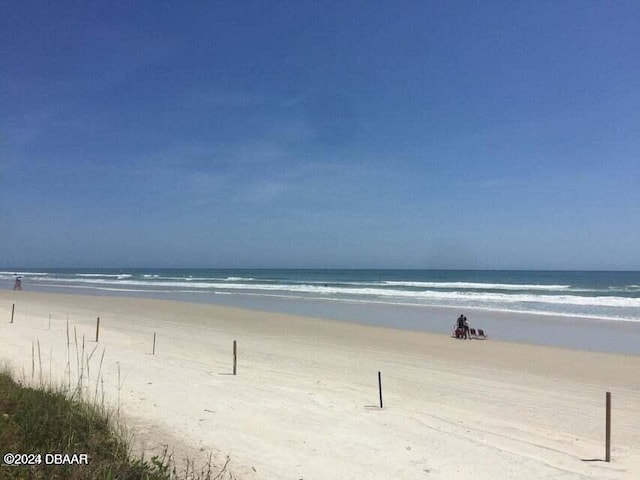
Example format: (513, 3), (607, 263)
(0, 268), (640, 354)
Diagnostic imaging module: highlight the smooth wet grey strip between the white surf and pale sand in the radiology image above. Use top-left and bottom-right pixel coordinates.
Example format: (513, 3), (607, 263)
(6, 288), (640, 355)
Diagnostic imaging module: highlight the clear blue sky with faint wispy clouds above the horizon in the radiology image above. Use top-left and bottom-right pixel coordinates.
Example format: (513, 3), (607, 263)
(0, 0), (640, 269)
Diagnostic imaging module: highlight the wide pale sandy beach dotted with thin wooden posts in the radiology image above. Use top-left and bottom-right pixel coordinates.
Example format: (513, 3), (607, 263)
(0, 291), (640, 480)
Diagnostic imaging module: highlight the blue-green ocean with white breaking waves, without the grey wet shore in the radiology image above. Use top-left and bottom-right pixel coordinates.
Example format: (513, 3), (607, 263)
(0, 269), (640, 322)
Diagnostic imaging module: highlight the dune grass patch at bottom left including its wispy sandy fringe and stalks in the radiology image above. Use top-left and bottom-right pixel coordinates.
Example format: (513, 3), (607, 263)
(0, 356), (233, 480)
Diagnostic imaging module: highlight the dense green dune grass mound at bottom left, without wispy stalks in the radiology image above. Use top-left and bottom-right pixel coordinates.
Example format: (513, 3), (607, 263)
(0, 372), (172, 480)
